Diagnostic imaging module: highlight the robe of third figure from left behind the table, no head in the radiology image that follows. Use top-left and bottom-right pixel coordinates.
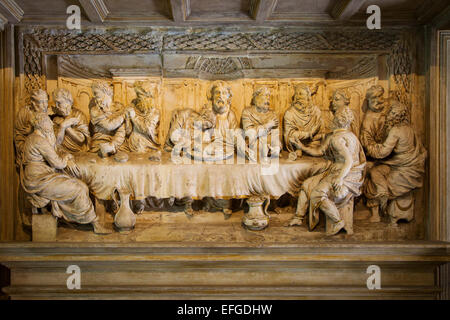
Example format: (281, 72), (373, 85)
(90, 100), (125, 152)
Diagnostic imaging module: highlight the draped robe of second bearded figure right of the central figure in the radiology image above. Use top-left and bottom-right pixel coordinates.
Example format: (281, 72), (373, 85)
(283, 105), (322, 152)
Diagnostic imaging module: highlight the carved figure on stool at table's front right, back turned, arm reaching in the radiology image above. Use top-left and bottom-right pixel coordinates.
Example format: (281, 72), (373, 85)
(290, 108), (366, 235)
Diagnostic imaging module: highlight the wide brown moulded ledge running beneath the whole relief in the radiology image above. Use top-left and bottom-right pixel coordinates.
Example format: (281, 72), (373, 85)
(0, 241), (450, 299)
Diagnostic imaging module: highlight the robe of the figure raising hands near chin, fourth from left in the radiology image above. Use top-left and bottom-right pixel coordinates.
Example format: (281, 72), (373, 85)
(127, 101), (160, 153)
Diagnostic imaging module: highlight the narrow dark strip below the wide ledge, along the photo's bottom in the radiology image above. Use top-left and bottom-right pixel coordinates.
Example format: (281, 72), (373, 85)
(0, 286), (440, 300)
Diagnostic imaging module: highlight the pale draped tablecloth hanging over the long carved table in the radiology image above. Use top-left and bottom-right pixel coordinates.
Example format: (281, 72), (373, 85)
(76, 153), (329, 200)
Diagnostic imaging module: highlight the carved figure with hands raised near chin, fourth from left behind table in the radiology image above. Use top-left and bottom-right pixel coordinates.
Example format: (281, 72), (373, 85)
(126, 81), (161, 156)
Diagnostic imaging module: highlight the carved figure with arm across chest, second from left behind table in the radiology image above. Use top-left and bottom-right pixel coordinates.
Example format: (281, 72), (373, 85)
(52, 89), (90, 152)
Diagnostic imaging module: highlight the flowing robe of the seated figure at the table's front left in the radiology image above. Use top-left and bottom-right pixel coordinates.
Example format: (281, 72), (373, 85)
(20, 132), (96, 224)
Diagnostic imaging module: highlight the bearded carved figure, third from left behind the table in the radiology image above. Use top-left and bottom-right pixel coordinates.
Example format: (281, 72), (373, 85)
(89, 81), (126, 157)
